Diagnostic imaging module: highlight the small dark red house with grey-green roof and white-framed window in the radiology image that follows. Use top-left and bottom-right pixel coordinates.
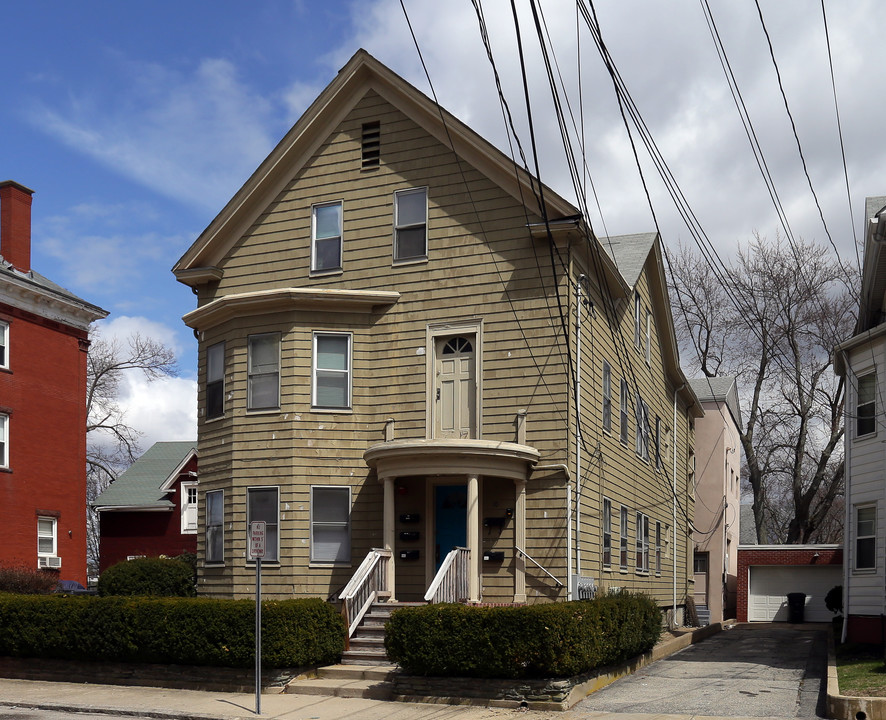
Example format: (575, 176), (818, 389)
(92, 441), (197, 572)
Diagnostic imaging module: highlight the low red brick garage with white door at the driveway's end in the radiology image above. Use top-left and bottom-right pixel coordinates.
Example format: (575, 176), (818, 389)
(737, 545), (843, 622)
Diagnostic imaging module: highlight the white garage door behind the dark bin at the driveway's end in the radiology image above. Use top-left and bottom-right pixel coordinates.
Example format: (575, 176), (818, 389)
(748, 565), (843, 622)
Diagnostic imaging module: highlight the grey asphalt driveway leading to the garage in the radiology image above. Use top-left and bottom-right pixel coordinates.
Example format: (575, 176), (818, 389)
(568, 623), (827, 719)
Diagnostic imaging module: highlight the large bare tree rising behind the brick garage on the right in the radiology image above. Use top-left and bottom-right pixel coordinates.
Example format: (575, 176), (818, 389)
(669, 233), (857, 543)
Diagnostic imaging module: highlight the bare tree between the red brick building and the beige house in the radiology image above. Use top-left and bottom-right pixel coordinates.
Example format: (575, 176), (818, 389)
(86, 330), (178, 568)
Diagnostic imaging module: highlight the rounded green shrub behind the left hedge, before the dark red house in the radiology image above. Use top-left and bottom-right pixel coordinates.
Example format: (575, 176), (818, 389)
(98, 558), (197, 597)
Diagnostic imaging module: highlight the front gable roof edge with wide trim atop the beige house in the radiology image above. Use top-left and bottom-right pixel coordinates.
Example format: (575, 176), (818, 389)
(172, 49), (579, 285)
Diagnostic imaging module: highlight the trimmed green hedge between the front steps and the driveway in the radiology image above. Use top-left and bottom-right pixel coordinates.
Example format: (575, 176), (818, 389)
(385, 593), (661, 678)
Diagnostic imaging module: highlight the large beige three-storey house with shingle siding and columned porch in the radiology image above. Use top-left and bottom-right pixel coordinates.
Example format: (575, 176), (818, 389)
(174, 51), (703, 624)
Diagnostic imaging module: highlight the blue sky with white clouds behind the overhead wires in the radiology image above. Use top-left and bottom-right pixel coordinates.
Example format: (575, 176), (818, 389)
(0, 0), (886, 447)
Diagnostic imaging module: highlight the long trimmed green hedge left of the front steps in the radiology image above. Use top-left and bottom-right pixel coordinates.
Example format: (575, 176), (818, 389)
(0, 594), (345, 668)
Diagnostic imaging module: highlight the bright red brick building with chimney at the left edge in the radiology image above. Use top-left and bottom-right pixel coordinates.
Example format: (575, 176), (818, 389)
(0, 180), (108, 585)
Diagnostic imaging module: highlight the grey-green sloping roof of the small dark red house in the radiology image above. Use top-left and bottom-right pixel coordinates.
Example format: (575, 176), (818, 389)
(91, 441), (197, 512)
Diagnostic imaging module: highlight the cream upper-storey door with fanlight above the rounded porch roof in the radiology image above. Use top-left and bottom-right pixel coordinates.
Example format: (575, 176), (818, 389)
(434, 335), (477, 438)
